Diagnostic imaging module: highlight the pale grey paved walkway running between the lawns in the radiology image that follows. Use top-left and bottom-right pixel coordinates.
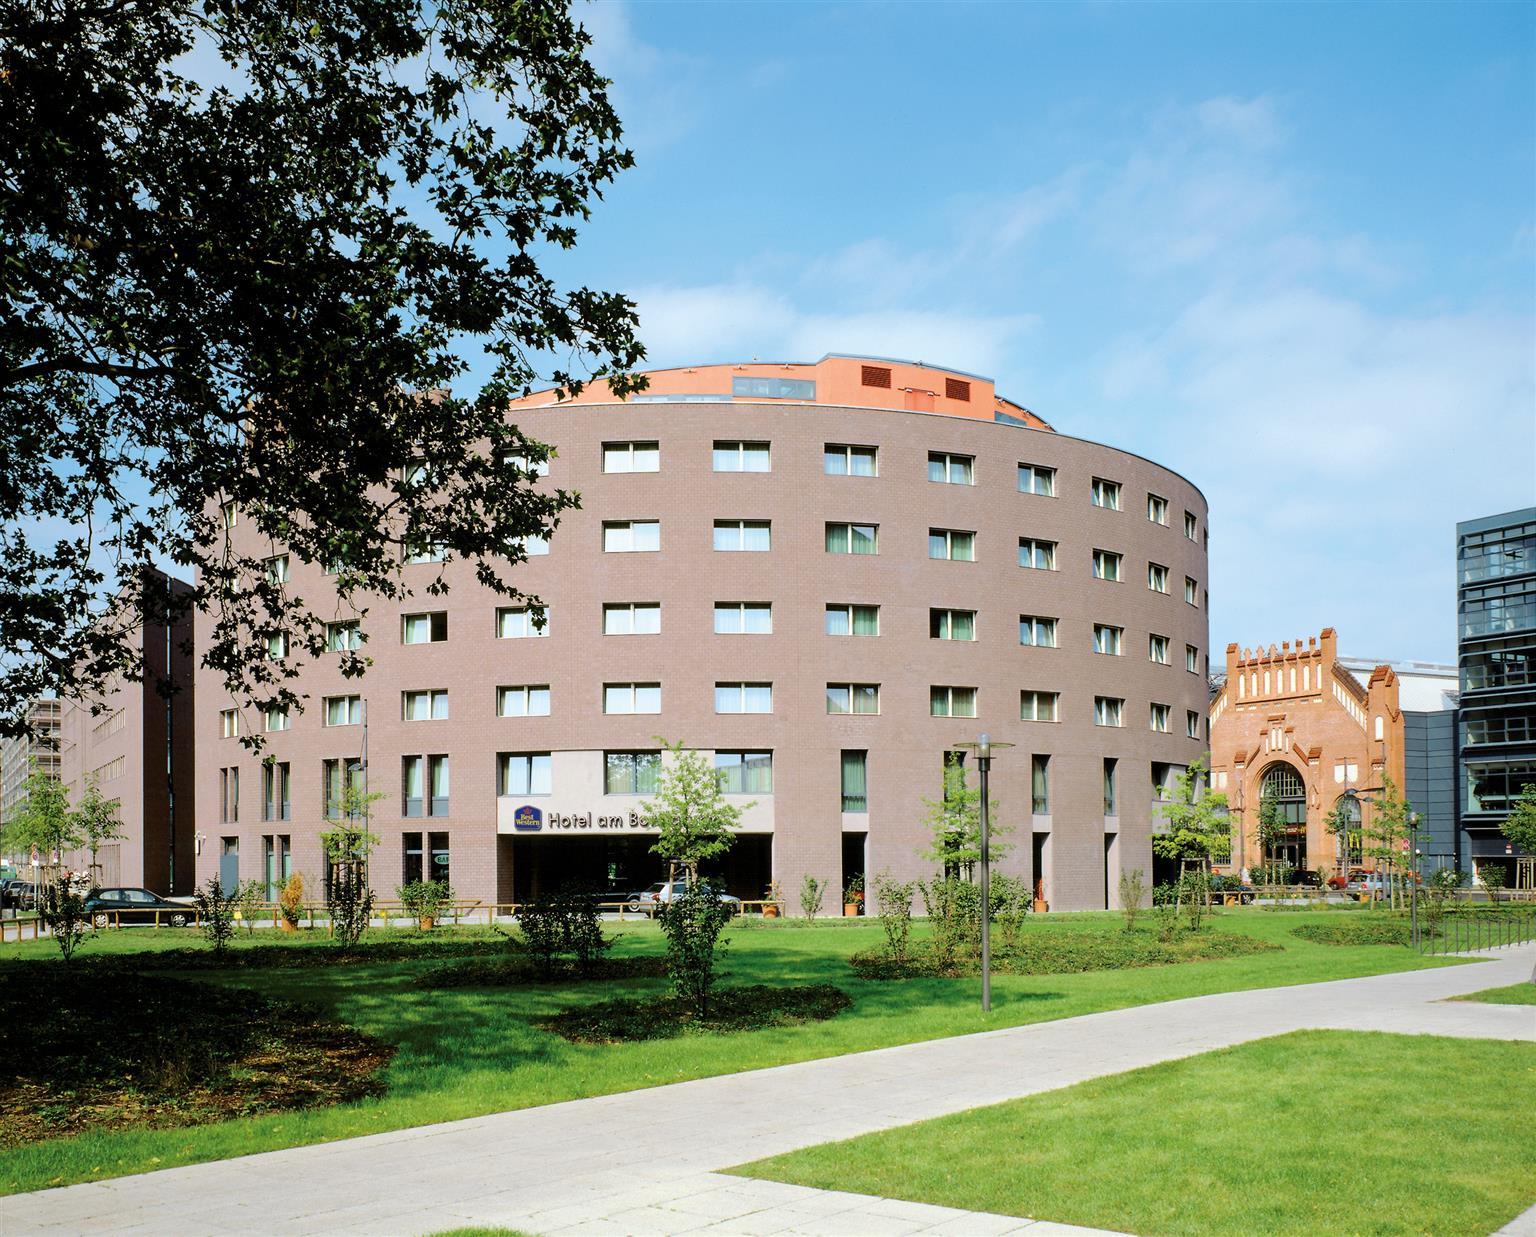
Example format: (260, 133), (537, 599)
(0, 945), (1536, 1237)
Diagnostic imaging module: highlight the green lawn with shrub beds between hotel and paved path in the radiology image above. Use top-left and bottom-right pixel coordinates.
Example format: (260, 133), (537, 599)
(0, 910), (1461, 1194)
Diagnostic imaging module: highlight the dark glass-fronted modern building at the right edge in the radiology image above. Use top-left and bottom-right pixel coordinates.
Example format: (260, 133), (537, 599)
(1456, 507), (1536, 887)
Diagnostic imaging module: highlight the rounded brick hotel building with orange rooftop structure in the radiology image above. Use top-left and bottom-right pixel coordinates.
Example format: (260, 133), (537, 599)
(195, 357), (1207, 910)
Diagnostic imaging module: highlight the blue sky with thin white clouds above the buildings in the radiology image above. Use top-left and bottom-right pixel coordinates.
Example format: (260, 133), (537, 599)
(531, 0), (1536, 664)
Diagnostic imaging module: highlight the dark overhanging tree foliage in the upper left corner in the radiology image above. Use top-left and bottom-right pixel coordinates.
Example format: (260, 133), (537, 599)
(0, 0), (644, 744)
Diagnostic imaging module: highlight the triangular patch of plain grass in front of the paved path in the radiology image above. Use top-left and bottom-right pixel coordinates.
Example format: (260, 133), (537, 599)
(734, 1031), (1536, 1234)
